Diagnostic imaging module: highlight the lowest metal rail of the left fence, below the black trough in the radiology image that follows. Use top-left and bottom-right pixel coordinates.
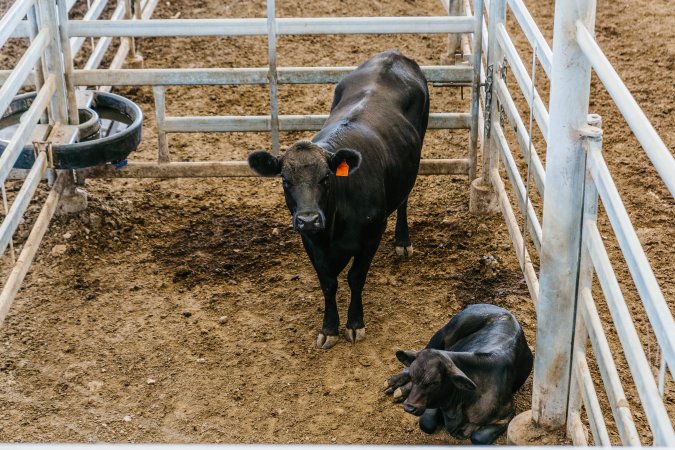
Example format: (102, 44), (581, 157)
(0, 172), (67, 326)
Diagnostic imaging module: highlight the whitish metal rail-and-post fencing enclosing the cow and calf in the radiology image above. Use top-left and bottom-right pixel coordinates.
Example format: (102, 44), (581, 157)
(0, 0), (675, 446)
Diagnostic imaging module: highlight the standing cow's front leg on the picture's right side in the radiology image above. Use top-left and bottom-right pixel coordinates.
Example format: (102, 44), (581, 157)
(345, 222), (386, 344)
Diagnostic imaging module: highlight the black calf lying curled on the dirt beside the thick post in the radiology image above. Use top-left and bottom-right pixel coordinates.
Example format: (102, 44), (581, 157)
(387, 305), (532, 445)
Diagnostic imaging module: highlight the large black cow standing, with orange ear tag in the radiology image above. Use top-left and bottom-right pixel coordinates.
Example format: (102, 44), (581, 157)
(248, 50), (429, 349)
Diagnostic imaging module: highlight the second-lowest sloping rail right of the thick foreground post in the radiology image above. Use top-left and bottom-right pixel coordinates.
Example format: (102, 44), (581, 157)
(579, 288), (642, 447)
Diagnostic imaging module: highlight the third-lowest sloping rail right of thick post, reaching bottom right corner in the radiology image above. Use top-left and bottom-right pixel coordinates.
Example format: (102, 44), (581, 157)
(583, 221), (675, 447)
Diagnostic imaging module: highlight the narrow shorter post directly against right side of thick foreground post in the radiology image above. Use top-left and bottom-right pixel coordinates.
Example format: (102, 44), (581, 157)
(567, 114), (602, 445)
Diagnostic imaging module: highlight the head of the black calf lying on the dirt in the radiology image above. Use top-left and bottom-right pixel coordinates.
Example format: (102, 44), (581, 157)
(396, 349), (476, 416)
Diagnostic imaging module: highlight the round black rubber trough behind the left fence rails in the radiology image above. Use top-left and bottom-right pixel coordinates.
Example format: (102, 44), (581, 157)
(0, 91), (143, 169)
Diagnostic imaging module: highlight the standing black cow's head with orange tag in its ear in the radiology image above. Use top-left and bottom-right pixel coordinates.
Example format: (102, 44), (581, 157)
(248, 141), (361, 233)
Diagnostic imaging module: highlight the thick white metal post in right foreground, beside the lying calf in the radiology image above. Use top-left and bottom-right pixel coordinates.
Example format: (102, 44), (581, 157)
(532, 0), (595, 428)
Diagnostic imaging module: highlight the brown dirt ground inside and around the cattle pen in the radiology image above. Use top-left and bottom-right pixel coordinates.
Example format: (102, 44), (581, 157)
(0, 0), (675, 444)
